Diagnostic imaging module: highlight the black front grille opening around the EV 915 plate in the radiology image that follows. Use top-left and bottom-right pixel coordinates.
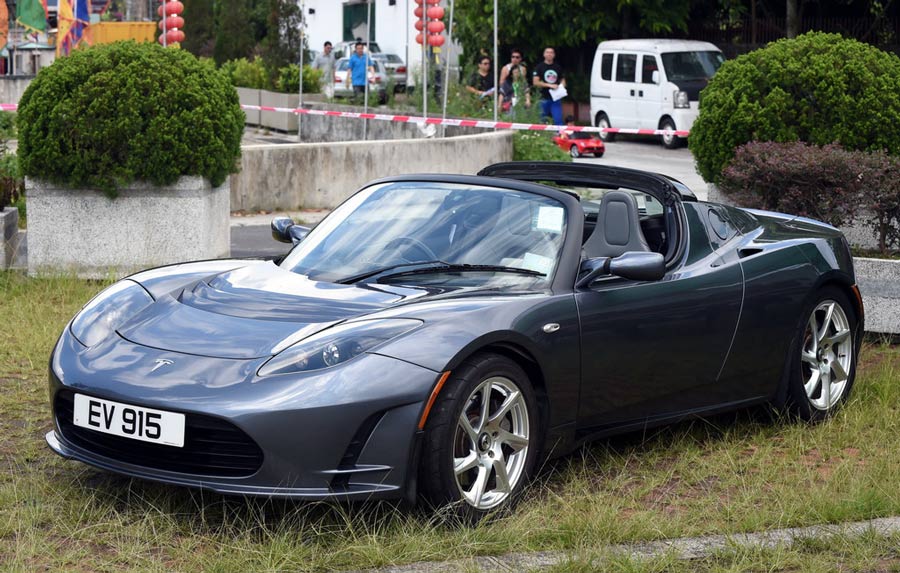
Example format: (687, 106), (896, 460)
(54, 390), (263, 477)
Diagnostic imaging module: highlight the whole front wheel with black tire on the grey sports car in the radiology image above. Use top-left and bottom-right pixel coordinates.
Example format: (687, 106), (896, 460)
(420, 354), (541, 522)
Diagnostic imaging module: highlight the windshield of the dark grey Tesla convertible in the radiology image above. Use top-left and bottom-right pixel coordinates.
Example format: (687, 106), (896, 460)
(281, 181), (566, 288)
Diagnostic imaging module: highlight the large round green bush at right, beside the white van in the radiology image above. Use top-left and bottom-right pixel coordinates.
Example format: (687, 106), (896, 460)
(689, 32), (900, 181)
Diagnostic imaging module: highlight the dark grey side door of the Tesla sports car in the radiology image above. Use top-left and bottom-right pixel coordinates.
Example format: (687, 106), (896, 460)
(576, 204), (743, 429)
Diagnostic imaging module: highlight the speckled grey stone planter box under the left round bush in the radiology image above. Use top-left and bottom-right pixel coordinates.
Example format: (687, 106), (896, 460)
(25, 176), (231, 278)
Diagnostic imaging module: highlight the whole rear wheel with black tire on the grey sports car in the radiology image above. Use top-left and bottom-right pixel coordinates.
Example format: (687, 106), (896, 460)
(785, 287), (861, 421)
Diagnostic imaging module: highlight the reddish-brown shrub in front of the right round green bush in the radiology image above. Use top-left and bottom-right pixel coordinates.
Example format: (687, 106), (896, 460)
(719, 142), (900, 252)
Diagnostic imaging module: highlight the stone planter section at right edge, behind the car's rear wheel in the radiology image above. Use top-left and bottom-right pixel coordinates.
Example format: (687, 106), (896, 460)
(853, 257), (900, 335)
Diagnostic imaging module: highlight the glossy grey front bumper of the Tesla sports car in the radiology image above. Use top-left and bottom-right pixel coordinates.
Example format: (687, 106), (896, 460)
(46, 333), (437, 500)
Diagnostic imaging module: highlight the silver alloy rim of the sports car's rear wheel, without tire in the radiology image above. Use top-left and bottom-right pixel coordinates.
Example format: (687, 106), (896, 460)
(800, 300), (853, 411)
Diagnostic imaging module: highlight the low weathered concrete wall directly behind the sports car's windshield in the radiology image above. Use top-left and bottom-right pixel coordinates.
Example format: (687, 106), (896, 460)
(232, 131), (512, 210)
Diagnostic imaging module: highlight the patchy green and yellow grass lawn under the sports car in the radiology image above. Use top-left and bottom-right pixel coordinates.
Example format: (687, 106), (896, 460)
(0, 272), (900, 571)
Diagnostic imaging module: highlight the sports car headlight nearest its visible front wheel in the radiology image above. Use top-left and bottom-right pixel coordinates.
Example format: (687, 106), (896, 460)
(257, 318), (422, 376)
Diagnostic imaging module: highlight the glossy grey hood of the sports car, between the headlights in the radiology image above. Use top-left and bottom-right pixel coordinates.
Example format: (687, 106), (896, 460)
(117, 264), (430, 359)
